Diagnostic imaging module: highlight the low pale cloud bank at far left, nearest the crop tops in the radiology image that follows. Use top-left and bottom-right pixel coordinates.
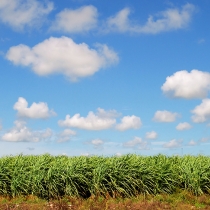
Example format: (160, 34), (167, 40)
(2, 121), (52, 142)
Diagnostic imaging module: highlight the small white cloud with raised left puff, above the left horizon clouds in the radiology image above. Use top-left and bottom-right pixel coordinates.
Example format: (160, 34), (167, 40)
(13, 97), (56, 119)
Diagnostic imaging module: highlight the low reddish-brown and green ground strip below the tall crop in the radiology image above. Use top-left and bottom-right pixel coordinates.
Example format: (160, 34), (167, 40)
(0, 191), (210, 210)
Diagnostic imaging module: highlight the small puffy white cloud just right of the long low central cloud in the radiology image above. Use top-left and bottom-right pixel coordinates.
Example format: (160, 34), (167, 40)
(116, 115), (142, 131)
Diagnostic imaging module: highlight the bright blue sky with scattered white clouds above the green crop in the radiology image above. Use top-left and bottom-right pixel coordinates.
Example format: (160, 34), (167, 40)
(0, 0), (210, 156)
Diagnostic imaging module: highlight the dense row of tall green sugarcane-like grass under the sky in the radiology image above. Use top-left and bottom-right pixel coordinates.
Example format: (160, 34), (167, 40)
(0, 154), (210, 199)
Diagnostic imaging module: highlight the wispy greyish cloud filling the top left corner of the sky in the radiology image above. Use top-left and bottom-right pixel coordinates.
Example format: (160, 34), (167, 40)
(0, 0), (54, 30)
